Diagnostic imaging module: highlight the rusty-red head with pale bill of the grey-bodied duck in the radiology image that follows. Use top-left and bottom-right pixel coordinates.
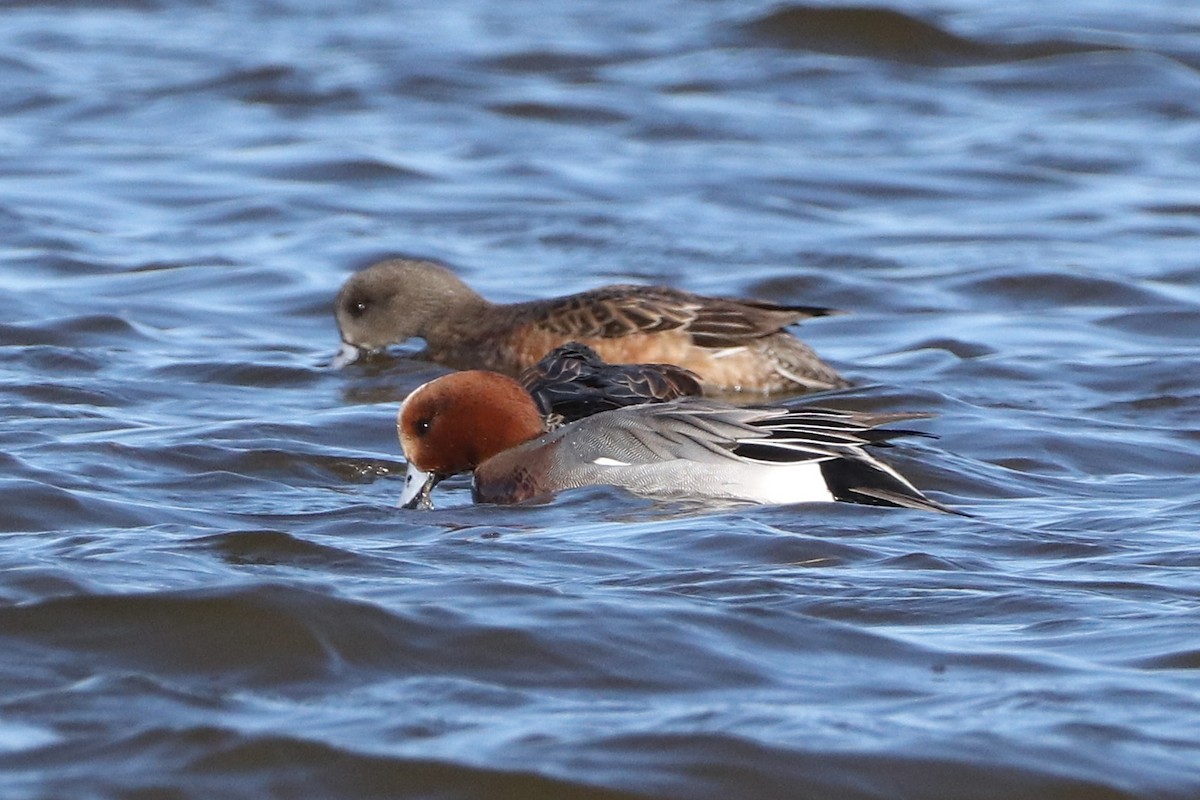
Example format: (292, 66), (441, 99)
(396, 369), (545, 507)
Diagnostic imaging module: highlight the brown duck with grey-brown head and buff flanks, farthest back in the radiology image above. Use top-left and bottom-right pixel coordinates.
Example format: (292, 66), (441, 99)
(335, 258), (848, 393)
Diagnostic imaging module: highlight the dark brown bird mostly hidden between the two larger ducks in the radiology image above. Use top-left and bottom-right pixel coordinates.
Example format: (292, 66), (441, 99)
(517, 342), (704, 427)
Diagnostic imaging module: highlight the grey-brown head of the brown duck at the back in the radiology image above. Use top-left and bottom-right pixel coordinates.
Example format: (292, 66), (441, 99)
(334, 258), (487, 361)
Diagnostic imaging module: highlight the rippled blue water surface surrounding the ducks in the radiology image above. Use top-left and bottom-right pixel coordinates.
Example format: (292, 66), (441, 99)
(0, 0), (1200, 799)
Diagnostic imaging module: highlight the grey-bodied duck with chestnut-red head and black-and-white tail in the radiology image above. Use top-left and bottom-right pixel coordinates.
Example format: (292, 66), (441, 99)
(397, 371), (949, 511)
